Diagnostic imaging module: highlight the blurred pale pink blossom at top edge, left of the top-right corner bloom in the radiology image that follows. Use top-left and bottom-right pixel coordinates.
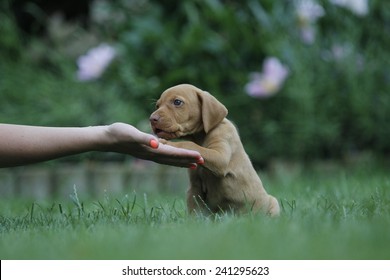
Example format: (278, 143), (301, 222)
(296, 0), (325, 44)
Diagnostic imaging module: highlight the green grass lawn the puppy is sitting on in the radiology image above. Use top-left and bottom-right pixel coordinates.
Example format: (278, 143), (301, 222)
(0, 160), (390, 259)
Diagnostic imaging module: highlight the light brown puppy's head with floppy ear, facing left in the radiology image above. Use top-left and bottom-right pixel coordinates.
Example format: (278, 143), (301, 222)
(149, 84), (227, 140)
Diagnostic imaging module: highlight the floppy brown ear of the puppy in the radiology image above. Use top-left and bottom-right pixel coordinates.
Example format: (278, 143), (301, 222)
(197, 90), (228, 133)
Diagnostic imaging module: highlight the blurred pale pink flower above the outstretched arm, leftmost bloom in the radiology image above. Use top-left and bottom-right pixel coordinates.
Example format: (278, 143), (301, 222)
(77, 44), (116, 81)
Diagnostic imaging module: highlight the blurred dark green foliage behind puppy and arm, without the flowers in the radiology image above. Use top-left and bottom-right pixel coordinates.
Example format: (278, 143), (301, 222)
(0, 0), (390, 164)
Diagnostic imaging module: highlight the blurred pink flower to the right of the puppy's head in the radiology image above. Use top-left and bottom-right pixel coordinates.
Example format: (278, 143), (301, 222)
(245, 57), (289, 98)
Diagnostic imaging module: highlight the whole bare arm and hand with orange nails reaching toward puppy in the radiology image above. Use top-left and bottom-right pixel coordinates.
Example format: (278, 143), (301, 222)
(0, 123), (201, 167)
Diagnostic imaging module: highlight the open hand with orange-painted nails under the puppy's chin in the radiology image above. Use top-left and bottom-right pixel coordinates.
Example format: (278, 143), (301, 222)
(102, 123), (203, 168)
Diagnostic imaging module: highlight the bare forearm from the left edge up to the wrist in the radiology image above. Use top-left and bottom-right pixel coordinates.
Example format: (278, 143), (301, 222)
(0, 124), (105, 167)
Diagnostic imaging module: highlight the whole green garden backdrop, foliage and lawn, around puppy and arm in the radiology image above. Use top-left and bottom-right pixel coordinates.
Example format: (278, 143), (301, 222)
(0, 0), (390, 260)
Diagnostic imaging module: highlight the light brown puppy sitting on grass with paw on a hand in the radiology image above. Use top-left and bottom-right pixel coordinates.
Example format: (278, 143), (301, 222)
(150, 84), (280, 216)
